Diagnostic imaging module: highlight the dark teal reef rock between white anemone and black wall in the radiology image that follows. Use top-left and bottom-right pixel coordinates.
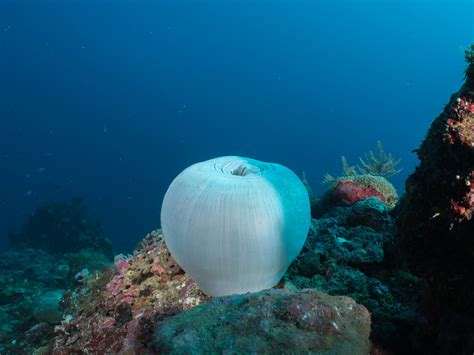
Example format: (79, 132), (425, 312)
(285, 197), (422, 353)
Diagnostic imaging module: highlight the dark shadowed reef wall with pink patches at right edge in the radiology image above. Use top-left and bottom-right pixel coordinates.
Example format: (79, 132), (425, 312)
(396, 45), (474, 353)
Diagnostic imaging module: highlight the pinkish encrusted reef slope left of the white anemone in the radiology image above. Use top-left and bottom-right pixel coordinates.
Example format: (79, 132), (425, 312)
(51, 231), (210, 354)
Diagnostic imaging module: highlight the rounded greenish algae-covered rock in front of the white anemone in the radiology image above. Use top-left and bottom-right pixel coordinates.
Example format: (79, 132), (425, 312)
(154, 289), (370, 354)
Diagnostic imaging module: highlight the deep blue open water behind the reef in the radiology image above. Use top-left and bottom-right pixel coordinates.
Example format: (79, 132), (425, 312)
(0, 0), (474, 251)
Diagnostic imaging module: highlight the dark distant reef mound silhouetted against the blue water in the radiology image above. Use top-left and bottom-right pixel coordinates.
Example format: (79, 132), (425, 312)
(9, 198), (113, 259)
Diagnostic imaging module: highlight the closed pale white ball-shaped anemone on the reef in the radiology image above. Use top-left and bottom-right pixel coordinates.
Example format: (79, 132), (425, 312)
(161, 156), (311, 296)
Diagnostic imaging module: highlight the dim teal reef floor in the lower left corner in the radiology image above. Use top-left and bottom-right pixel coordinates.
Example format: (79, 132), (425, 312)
(0, 248), (110, 354)
